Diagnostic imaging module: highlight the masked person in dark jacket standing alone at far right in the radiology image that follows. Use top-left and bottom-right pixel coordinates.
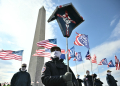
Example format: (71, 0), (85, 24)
(106, 70), (118, 86)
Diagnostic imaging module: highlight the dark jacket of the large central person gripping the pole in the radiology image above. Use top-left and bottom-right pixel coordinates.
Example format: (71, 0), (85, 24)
(41, 58), (77, 86)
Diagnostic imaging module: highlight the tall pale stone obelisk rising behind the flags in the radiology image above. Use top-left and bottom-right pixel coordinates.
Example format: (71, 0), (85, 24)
(28, 7), (46, 86)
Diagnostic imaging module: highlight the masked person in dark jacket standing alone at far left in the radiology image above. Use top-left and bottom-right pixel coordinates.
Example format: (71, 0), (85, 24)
(11, 64), (31, 86)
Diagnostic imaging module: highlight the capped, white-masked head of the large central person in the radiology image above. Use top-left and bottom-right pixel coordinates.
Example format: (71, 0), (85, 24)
(50, 46), (61, 59)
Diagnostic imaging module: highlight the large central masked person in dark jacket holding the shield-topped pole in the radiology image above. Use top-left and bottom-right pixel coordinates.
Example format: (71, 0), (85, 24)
(41, 46), (78, 86)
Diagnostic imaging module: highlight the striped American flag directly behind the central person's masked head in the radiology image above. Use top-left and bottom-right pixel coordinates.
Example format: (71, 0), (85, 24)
(33, 49), (65, 58)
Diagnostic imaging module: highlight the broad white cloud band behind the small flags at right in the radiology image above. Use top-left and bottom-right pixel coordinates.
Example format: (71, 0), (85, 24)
(91, 40), (120, 62)
